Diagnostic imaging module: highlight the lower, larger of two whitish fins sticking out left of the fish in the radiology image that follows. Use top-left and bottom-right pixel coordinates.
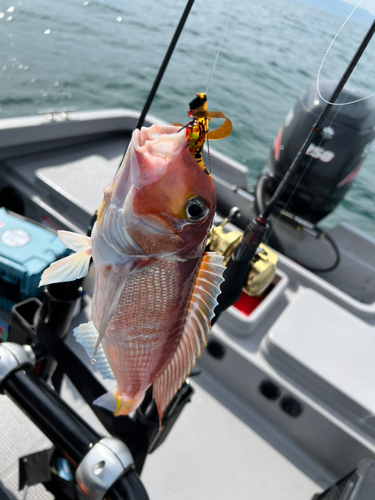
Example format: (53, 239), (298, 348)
(39, 247), (91, 286)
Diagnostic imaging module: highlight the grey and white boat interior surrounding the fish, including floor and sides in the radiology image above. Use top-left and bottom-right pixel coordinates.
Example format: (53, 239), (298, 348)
(0, 111), (375, 500)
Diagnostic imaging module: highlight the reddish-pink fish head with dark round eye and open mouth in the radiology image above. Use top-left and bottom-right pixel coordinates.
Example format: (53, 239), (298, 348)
(97, 125), (216, 255)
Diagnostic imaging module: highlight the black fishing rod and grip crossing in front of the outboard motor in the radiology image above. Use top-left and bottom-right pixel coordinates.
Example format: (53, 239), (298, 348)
(212, 20), (375, 324)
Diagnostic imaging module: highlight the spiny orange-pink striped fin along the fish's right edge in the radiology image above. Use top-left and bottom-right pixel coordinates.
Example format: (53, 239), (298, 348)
(153, 252), (225, 421)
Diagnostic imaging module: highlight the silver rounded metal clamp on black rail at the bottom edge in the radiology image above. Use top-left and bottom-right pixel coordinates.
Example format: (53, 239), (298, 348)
(76, 437), (134, 500)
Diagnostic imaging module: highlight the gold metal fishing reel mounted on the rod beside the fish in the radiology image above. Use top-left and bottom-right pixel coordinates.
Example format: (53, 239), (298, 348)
(207, 207), (278, 297)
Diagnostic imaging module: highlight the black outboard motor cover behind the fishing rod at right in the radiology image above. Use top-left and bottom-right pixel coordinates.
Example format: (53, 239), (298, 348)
(256, 81), (375, 225)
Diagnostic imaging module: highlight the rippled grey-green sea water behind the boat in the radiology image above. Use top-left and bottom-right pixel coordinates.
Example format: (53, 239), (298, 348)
(0, 0), (375, 236)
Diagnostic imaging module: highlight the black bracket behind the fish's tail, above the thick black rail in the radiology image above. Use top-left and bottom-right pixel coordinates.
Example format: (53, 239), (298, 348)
(9, 288), (194, 474)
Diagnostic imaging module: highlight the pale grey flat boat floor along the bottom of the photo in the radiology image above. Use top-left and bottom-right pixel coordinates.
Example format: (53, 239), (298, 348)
(0, 300), (324, 500)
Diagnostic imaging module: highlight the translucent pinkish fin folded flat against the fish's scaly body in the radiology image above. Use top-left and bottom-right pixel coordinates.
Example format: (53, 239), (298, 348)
(93, 260), (134, 357)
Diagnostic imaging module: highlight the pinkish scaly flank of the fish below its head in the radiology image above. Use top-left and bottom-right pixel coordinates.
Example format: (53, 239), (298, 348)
(103, 261), (194, 398)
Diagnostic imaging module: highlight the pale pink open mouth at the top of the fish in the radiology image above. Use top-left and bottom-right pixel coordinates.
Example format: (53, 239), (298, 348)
(133, 125), (187, 161)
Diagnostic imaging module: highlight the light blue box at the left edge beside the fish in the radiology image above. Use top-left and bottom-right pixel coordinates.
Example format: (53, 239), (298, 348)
(0, 208), (71, 309)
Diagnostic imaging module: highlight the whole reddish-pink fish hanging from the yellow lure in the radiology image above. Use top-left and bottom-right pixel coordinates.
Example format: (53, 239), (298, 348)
(40, 125), (225, 422)
